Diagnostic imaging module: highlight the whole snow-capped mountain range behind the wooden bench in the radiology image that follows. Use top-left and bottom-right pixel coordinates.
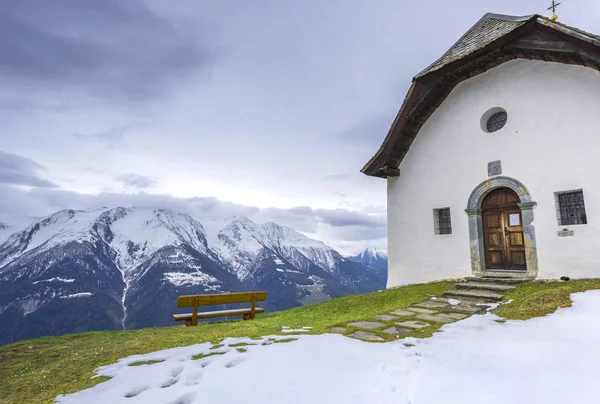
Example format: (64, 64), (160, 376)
(0, 207), (385, 344)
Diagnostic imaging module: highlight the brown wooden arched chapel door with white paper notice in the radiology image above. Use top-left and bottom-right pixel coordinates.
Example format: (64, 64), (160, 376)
(481, 188), (527, 271)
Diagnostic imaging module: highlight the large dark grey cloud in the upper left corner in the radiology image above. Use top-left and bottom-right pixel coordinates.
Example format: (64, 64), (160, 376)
(0, 0), (212, 99)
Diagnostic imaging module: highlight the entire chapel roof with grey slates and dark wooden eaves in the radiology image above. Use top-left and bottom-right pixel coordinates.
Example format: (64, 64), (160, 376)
(361, 13), (600, 178)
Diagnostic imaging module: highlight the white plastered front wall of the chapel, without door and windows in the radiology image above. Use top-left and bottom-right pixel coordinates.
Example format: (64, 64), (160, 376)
(387, 60), (600, 287)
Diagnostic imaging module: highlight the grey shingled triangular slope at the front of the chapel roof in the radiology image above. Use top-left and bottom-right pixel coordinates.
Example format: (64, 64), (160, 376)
(416, 13), (536, 77)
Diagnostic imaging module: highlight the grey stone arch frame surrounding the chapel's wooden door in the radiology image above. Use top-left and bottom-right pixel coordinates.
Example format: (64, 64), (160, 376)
(465, 176), (538, 278)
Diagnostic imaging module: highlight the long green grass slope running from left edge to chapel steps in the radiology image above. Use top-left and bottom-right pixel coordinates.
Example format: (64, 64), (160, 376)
(0, 282), (454, 404)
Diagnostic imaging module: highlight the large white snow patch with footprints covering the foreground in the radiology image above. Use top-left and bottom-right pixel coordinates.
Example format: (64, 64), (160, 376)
(57, 291), (600, 404)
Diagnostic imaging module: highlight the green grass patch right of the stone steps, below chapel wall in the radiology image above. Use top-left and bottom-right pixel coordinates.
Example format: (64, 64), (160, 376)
(494, 279), (600, 320)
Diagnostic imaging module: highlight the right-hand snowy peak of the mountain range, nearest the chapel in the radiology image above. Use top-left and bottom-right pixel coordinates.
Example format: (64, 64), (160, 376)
(212, 218), (384, 309)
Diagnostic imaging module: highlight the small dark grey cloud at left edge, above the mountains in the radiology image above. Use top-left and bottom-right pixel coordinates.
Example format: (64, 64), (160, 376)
(0, 151), (56, 188)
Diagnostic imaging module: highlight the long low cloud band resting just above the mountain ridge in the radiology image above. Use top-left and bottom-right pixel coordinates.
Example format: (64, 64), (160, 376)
(0, 185), (387, 247)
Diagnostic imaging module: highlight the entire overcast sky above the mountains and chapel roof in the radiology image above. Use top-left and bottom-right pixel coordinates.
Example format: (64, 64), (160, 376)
(0, 0), (600, 253)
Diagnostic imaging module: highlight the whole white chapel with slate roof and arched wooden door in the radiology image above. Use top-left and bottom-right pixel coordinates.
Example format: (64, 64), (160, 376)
(362, 14), (600, 287)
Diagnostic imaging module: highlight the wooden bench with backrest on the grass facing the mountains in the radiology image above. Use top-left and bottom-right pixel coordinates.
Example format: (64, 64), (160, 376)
(173, 292), (267, 325)
